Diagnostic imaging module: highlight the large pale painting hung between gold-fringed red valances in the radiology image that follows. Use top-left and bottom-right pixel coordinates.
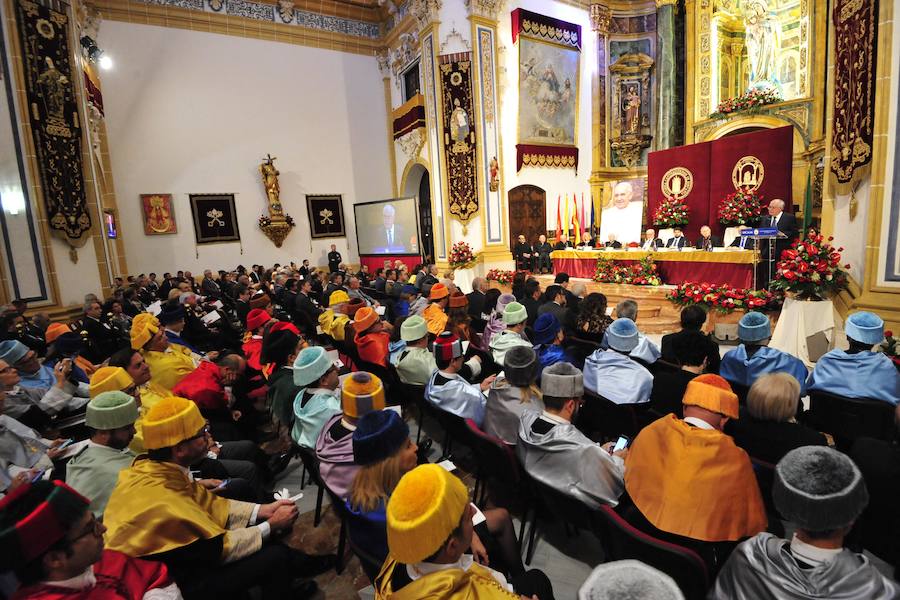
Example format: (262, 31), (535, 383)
(512, 8), (581, 171)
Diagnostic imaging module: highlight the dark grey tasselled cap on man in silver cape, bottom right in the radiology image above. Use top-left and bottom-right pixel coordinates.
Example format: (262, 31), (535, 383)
(772, 446), (869, 532)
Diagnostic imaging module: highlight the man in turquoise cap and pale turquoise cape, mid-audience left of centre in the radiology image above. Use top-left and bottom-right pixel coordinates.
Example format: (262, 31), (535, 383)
(291, 344), (343, 448)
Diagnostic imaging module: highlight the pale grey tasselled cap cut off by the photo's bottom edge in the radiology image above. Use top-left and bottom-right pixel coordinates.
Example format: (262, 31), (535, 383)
(578, 560), (684, 600)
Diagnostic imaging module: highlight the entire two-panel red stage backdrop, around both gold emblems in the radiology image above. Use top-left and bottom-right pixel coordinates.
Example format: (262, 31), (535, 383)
(647, 125), (794, 242)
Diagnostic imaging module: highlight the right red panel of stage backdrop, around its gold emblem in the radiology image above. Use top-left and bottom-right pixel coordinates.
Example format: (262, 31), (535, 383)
(708, 125), (794, 235)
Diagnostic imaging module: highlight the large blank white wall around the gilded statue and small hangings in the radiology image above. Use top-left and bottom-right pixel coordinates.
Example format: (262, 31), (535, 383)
(100, 21), (391, 273)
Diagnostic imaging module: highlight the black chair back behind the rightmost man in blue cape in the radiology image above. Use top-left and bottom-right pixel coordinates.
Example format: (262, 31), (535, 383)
(807, 390), (895, 449)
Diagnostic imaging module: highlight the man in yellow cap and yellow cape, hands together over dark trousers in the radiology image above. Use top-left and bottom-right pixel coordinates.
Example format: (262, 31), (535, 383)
(103, 397), (330, 598)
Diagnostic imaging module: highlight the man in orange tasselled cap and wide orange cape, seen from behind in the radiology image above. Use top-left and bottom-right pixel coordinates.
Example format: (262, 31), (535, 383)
(625, 374), (767, 542)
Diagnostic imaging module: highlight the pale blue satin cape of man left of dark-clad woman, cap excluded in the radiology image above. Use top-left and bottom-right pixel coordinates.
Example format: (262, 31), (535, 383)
(584, 350), (653, 404)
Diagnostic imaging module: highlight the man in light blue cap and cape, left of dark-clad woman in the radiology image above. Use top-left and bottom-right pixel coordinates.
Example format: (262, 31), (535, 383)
(584, 318), (653, 404)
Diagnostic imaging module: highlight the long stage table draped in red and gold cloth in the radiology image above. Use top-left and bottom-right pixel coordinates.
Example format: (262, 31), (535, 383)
(550, 250), (754, 288)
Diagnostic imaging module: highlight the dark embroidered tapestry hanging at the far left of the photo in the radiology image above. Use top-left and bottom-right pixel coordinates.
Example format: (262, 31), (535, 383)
(16, 0), (91, 248)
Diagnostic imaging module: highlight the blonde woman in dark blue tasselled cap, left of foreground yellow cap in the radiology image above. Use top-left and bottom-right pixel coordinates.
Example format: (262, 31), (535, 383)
(346, 410), (525, 576)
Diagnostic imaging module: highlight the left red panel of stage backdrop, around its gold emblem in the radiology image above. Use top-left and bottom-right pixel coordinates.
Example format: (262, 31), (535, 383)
(647, 142), (712, 242)
